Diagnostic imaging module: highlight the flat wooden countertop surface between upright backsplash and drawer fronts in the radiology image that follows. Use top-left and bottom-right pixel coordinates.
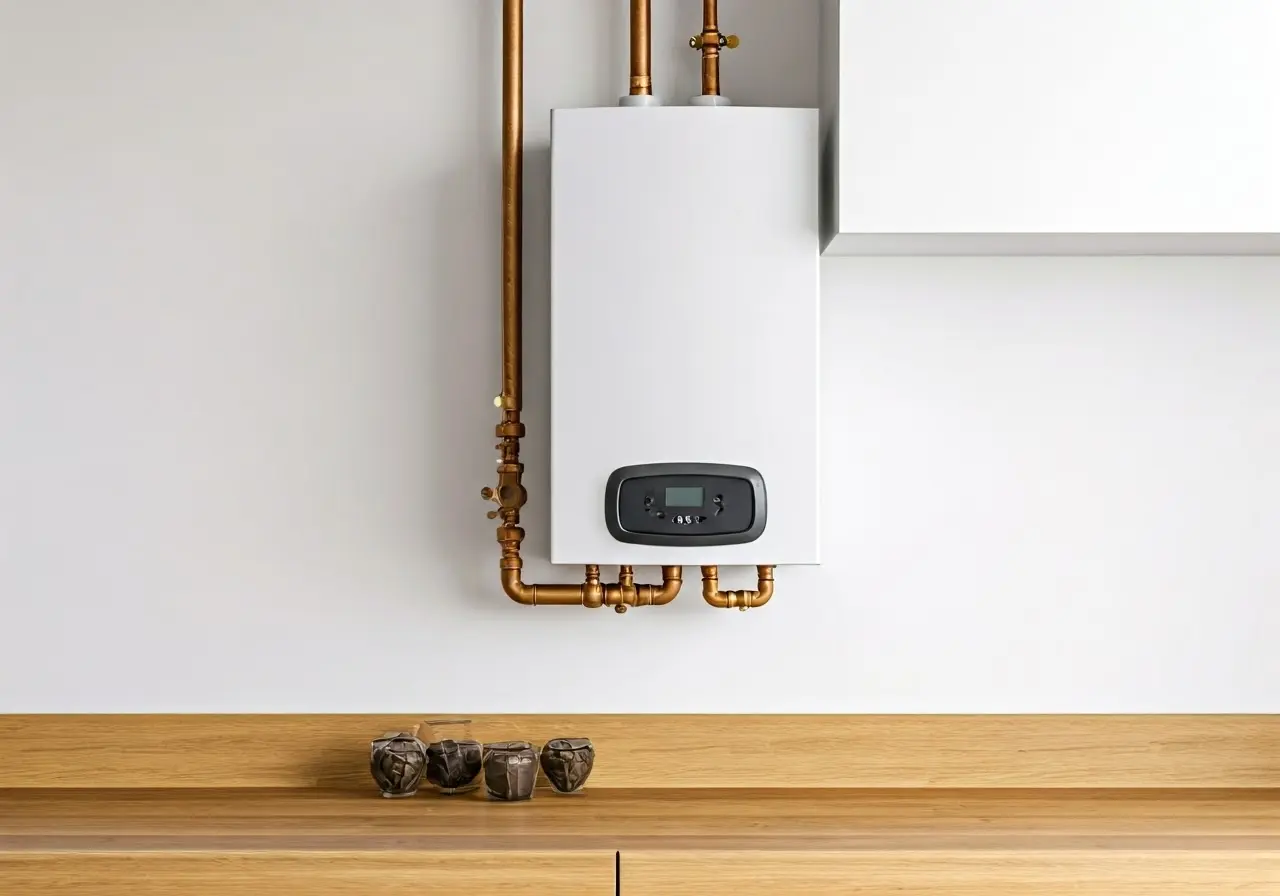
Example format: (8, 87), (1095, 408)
(0, 788), (1280, 851)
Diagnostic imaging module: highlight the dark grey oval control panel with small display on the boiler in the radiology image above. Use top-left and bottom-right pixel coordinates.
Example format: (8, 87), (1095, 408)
(604, 463), (768, 547)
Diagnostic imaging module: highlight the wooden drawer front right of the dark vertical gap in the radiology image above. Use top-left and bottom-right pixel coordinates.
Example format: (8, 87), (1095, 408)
(621, 849), (1280, 896)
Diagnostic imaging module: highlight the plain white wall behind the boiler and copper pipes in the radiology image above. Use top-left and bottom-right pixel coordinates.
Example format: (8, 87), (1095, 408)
(0, 0), (1280, 712)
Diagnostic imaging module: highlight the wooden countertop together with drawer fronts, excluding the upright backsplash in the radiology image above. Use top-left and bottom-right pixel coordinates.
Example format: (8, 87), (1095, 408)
(0, 787), (1280, 896)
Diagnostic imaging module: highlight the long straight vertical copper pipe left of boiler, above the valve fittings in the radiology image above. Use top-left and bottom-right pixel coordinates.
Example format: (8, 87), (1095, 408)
(500, 0), (525, 412)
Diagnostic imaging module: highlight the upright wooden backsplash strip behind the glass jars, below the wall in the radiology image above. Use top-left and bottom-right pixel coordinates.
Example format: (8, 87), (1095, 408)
(0, 713), (1280, 790)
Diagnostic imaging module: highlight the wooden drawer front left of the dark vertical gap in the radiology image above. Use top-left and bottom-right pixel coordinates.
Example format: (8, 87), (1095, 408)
(0, 851), (614, 896)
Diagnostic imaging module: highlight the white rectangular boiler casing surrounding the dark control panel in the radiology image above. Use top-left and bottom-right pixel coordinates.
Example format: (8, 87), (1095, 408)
(550, 106), (819, 566)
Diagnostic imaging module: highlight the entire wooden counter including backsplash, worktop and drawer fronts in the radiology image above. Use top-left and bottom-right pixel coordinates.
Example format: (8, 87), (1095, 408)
(10, 716), (1280, 896)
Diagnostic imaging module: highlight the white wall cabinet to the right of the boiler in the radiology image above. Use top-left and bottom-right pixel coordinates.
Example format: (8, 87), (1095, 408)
(822, 0), (1280, 255)
